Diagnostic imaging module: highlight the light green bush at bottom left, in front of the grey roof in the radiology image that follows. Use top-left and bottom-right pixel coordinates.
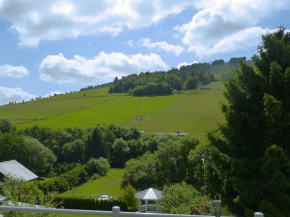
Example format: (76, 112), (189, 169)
(1, 176), (56, 217)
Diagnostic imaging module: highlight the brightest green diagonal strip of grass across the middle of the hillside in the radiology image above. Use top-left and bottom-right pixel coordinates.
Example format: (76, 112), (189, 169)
(17, 94), (183, 129)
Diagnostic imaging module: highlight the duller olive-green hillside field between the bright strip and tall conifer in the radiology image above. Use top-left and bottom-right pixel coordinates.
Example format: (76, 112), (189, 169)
(123, 82), (225, 137)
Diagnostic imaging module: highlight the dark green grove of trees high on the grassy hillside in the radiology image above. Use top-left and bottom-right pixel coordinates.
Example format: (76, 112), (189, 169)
(109, 65), (214, 96)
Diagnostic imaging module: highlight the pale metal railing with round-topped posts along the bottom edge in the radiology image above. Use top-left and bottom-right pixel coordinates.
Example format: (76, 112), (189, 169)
(0, 206), (264, 217)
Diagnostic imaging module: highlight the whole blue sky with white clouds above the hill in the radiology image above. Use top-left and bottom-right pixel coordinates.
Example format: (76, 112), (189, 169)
(0, 0), (290, 105)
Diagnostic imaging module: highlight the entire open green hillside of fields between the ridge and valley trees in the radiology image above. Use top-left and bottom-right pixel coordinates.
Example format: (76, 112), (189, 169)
(0, 82), (224, 136)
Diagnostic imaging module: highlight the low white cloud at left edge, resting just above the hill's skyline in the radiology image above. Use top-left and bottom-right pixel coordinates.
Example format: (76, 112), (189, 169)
(0, 87), (35, 105)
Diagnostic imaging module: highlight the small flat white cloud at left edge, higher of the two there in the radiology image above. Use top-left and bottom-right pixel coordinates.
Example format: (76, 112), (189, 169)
(0, 64), (29, 78)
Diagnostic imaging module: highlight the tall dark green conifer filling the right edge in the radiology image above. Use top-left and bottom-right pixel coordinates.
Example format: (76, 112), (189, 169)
(207, 28), (290, 217)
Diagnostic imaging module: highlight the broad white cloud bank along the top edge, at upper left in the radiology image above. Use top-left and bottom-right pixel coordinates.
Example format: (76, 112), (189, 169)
(0, 0), (193, 47)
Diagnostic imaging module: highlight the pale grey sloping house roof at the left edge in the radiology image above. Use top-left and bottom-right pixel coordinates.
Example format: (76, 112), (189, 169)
(0, 160), (38, 181)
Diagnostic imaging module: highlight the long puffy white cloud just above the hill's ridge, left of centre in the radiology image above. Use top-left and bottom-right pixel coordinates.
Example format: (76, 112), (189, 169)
(39, 52), (168, 84)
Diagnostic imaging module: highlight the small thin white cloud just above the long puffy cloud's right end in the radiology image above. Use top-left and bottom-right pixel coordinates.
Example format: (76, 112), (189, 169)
(139, 38), (184, 56)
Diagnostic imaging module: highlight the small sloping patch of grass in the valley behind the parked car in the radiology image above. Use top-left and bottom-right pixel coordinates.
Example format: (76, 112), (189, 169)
(61, 169), (124, 199)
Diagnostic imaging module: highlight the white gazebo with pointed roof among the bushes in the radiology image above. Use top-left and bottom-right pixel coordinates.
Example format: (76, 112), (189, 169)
(135, 188), (162, 213)
